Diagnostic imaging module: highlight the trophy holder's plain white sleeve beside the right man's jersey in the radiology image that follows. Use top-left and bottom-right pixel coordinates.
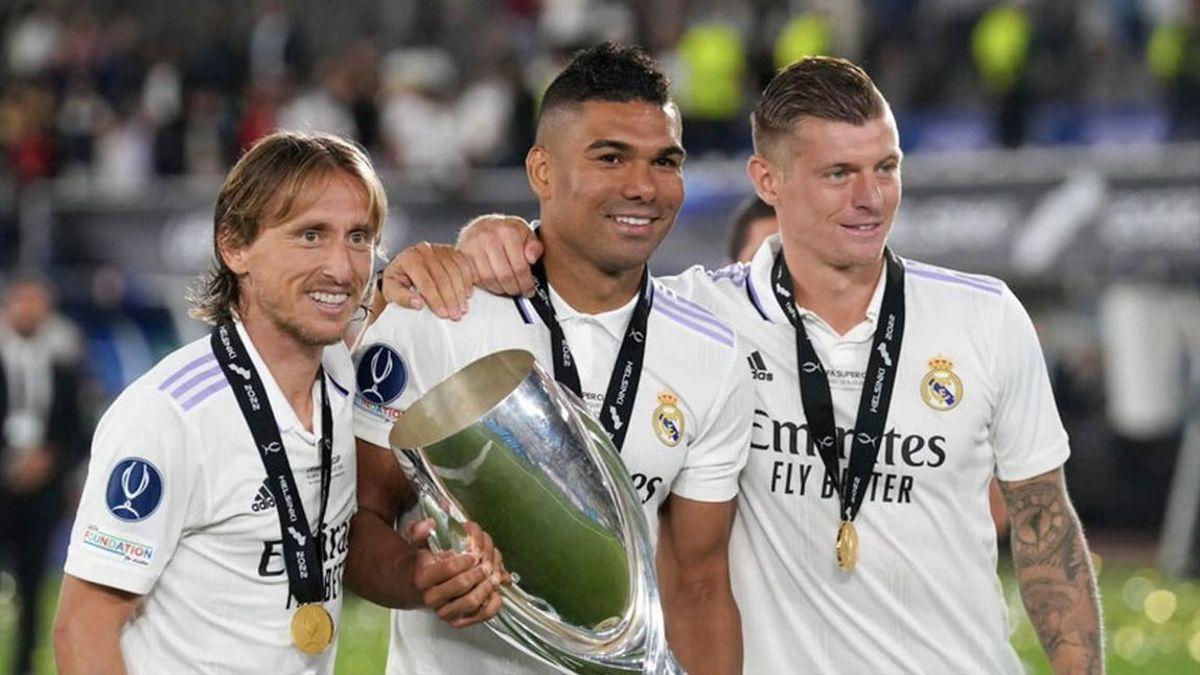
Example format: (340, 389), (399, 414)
(671, 341), (755, 502)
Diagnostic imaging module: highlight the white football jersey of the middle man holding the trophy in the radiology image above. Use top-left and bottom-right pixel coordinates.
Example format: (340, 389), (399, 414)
(355, 280), (754, 675)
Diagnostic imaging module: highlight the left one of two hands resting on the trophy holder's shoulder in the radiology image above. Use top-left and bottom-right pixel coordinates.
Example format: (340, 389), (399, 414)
(383, 241), (475, 321)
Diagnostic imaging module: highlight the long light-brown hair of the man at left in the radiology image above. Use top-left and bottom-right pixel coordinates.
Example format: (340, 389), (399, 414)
(187, 132), (388, 323)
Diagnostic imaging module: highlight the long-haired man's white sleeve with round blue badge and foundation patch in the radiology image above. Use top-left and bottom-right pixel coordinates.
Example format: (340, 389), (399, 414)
(65, 388), (204, 595)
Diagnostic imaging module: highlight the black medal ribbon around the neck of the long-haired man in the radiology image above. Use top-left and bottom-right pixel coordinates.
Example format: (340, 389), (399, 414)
(211, 323), (334, 604)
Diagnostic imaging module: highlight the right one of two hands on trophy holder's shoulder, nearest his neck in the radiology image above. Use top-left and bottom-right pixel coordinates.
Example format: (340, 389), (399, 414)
(457, 214), (542, 297)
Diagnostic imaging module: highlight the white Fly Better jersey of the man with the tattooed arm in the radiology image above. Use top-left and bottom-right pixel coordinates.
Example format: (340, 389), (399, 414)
(676, 235), (1069, 675)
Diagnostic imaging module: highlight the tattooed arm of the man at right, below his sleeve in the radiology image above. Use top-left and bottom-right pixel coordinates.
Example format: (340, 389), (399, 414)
(1000, 468), (1104, 675)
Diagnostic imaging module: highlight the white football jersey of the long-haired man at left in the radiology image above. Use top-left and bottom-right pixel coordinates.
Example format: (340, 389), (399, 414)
(66, 325), (356, 674)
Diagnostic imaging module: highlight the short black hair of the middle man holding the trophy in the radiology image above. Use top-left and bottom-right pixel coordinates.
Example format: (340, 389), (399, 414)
(539, 42), (671, 121)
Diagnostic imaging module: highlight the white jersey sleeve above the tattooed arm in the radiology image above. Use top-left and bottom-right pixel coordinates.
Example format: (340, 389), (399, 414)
(991, 287), (1070, 480)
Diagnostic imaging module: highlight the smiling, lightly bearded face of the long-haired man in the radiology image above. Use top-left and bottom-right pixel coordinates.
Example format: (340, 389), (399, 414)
(221, 169), (376, 347)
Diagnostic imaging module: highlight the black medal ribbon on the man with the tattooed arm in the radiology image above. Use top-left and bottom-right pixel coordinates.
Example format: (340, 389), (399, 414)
(772, 250), (905, 522)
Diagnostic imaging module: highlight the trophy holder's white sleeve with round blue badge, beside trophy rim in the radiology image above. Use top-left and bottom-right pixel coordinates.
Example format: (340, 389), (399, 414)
(354, 305), (451, 448)
